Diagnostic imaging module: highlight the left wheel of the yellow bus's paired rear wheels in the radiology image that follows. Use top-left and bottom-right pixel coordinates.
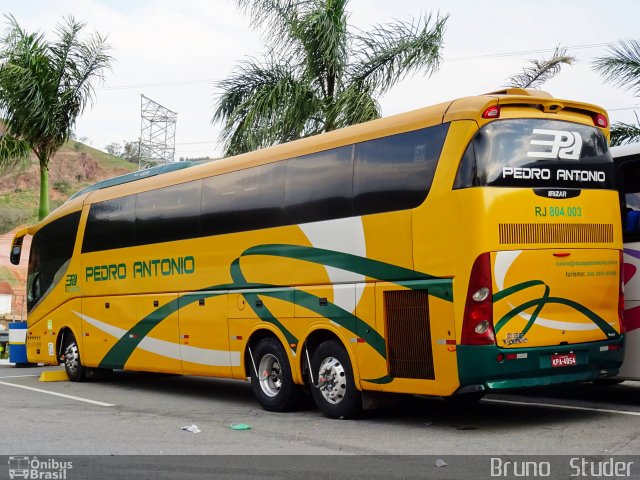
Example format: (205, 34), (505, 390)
(250, 337), (302, 412)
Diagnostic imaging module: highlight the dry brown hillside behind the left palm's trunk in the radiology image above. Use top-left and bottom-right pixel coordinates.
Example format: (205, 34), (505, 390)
(0, 140), (138, 235)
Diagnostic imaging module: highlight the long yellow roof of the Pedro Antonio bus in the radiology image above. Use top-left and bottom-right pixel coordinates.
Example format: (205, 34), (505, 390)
(52, 88), (606, 213)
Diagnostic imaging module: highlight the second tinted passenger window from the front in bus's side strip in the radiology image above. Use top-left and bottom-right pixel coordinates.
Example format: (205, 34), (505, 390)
(135, 180), (202, 245)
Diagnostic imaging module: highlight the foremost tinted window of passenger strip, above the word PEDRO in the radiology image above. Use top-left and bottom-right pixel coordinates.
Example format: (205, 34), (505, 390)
(82, 195), (136, 253)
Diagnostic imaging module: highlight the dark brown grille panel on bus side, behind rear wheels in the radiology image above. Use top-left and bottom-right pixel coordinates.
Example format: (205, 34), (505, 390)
(384, 290), (435, 380)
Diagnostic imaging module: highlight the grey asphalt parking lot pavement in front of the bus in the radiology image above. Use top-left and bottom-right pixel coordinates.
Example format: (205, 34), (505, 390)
(0, 365), (640, 455)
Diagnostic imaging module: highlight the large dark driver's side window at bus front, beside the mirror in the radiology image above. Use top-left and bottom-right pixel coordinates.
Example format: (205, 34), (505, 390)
(27, 212), (80, 311)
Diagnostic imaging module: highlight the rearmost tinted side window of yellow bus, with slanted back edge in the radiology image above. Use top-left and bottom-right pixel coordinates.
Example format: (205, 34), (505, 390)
(353, 124), (449, 215)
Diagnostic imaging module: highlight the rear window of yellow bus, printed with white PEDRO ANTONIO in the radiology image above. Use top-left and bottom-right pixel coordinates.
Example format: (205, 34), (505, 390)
(454, 118), (615, 189)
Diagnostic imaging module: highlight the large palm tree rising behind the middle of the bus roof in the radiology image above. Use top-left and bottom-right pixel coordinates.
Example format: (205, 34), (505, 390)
(212, 0), (448, 155)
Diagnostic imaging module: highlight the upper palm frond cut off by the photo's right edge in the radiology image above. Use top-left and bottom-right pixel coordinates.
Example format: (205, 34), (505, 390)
(593, 40), (640, 95)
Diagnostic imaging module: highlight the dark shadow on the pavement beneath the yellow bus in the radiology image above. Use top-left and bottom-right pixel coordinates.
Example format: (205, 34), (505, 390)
(92, 372), (640, 431)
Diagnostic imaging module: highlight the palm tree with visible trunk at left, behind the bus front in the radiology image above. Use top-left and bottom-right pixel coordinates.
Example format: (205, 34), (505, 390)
(0, 16), (111, 219)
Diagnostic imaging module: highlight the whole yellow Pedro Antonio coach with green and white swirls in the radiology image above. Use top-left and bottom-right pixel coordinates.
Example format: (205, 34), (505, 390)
(11, 90), (623, 417)
